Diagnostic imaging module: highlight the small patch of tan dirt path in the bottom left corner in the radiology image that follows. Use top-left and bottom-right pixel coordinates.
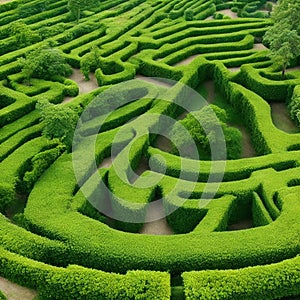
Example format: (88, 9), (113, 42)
(0, 277), (37, 300)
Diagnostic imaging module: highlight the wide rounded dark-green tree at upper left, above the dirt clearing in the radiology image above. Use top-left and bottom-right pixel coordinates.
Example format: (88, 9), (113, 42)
(18, 42), (72, 83)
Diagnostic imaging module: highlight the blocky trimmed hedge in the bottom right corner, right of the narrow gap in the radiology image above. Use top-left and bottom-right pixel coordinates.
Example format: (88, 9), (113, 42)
(182, 256), (300, 300)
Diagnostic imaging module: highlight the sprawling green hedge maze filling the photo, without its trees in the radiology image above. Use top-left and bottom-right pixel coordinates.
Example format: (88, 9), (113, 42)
(0, 0), (300, 299)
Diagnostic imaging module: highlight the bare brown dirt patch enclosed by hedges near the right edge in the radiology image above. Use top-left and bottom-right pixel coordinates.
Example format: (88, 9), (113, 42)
(270, 103), (299, 133)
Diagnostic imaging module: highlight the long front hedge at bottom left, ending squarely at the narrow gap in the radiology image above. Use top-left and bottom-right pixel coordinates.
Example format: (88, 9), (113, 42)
(0, 248), (171, 300)
